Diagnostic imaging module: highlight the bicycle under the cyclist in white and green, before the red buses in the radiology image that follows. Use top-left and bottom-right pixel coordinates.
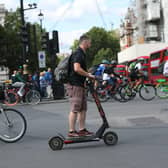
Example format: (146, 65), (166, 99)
(120, 81), (156, 101)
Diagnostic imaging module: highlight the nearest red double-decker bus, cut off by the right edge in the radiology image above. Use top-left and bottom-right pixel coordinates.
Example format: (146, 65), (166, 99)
(150, 47), (168, 84)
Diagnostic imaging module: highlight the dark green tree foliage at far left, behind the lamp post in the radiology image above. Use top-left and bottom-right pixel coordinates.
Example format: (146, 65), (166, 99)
(0, 9), (44, 71)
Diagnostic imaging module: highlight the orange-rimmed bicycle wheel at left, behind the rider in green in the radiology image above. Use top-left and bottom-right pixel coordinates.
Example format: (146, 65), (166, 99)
(4, 91), (19, 106)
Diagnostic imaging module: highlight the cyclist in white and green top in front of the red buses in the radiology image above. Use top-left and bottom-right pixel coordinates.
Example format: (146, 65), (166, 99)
(129, 58), (144, 90)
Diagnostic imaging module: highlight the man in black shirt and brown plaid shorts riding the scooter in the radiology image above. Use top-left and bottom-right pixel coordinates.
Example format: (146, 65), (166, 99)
(67, 35), (95, 137)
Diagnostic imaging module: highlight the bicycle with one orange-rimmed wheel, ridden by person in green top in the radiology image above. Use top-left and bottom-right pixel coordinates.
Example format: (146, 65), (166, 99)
(4, 83), (41, 106)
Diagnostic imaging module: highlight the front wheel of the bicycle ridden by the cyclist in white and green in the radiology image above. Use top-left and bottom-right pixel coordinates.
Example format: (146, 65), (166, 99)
(139, 85), (156, 101)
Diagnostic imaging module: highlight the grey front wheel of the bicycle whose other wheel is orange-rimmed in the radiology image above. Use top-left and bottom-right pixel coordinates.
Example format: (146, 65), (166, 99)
(25, 90), (41, 105)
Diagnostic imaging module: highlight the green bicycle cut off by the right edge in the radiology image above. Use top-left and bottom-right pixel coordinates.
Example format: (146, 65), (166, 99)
(155, 79), (168, 99)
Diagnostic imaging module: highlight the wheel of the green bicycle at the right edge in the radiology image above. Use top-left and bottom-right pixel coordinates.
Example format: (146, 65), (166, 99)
(156, 85), (168, 99)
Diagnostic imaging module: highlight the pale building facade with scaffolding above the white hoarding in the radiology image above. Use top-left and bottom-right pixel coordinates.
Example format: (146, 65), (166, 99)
(120, 0), (168, 50)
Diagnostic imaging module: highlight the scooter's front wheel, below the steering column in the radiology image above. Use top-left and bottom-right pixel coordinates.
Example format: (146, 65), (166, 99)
(103, 131), (118, 145)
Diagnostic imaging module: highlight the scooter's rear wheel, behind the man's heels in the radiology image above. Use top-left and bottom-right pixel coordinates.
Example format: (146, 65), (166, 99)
(48, 136), (64, 150)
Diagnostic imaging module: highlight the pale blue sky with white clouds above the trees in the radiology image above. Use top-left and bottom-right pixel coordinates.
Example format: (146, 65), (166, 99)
(0, 0), (130, 52)
